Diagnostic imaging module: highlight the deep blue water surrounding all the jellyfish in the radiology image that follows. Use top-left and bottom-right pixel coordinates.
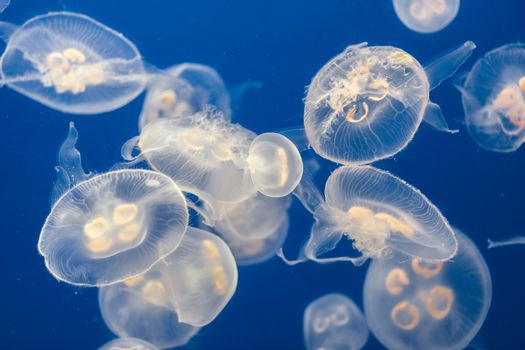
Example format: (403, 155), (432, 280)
(0, 0), (525, 349)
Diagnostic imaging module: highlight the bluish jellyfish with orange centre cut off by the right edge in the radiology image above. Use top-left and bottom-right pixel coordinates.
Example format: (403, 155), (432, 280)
(457, 44), (525, 152)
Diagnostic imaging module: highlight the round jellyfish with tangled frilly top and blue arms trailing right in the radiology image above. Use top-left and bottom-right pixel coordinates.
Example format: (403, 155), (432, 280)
(304, 41), (475, 165)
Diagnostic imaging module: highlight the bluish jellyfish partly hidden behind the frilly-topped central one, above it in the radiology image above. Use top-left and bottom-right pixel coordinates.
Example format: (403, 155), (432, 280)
(139, 63), (231, 130)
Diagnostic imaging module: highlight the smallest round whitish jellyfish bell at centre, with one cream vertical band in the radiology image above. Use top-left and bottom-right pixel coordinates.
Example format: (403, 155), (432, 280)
(248, 133), (303, 197)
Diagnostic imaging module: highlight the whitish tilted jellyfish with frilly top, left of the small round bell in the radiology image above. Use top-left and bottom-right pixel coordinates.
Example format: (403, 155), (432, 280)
(137, 110), (256, 202)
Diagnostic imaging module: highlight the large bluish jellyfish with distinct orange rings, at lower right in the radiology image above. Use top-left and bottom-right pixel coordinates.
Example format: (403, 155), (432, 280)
(363, 230), (492, 350)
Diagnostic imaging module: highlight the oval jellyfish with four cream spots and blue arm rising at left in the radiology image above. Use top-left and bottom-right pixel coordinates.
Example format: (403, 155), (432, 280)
(38, 123), (188, 286)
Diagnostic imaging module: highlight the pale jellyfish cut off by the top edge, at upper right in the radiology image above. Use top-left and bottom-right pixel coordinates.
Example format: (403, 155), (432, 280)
(393, 0), (459, 34)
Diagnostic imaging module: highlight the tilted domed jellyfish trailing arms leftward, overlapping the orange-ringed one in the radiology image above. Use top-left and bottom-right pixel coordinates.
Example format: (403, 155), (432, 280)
(278, 166), (457, 265)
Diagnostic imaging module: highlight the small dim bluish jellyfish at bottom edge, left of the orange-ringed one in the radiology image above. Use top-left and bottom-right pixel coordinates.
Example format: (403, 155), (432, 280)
(303, 293), (368, 350)
